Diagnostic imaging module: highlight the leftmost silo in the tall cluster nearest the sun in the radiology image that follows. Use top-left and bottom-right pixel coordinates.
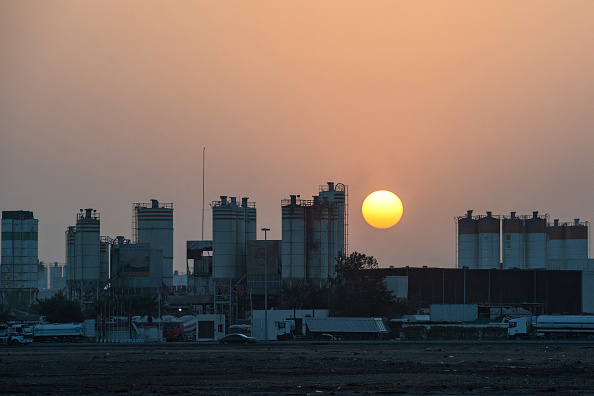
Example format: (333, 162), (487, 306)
(281, 195), (306, 280)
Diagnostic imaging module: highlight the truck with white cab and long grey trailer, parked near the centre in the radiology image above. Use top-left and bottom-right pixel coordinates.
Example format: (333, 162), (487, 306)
(276, 317), (388, 341)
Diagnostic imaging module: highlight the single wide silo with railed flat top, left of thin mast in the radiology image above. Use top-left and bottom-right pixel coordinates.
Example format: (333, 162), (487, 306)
(133, 199), (173, 286)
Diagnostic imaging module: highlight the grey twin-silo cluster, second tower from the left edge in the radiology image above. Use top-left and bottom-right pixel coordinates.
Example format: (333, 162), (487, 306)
(66, 209), (101, 299)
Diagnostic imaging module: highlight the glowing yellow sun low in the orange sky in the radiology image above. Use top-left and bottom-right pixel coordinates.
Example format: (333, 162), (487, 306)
(361, 190), (403, 228)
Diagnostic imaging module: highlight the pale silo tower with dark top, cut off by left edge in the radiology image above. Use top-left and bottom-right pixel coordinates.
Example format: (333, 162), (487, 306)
(0, 210), (39, 306)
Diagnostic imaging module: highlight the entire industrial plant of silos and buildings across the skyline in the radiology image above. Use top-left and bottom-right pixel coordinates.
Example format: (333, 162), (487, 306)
(0, 190), (594, 340)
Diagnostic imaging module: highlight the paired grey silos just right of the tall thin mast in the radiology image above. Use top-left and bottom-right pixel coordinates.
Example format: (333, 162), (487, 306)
(211, 195), (257, 280)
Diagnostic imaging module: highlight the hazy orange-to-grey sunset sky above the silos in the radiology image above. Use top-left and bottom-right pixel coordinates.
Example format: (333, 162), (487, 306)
(0, 0), (594, 272)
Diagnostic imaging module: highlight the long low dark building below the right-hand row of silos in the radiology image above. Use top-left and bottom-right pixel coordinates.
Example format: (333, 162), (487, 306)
(373, 267), (594, 315)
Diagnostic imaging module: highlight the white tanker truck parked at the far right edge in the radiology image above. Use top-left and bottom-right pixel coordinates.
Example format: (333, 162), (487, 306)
(507, 315), (594, 339)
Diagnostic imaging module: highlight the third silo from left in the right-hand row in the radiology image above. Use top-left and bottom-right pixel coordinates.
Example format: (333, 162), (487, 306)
(502, 212), (526, 269)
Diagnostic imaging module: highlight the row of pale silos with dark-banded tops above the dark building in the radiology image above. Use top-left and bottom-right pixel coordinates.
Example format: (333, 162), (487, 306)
(456, 210), (594, 269)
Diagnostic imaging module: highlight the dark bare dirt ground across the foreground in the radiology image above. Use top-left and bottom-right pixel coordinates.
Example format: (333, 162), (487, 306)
(0, 341), (594, 395)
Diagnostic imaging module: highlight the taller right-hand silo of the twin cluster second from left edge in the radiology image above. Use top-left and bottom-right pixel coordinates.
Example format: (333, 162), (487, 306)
(74, 209), (101, 282)
